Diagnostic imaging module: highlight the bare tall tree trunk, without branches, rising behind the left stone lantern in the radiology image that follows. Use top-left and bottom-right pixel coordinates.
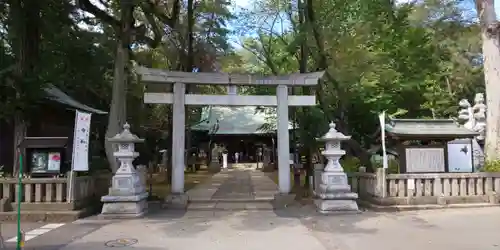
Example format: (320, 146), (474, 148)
(105, 1), (135, 172)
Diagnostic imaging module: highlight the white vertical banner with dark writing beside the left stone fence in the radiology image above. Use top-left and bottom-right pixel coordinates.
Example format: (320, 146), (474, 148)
(71, 110), (91, 172)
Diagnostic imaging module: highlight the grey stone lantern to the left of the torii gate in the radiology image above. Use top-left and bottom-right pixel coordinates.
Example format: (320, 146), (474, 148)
(101, 123), (148, 218)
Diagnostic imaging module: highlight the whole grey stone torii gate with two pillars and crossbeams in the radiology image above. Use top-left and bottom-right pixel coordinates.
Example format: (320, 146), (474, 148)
(137, 67), (324, 195)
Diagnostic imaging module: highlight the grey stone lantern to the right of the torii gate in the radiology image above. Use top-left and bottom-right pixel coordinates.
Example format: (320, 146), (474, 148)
(314, 122), (359, 213)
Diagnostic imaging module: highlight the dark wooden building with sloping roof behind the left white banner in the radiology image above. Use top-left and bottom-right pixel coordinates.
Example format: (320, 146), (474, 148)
(0, 86), (107, 175)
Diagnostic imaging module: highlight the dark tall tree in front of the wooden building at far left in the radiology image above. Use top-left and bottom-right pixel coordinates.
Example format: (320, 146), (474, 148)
(2, 0), (47, 173)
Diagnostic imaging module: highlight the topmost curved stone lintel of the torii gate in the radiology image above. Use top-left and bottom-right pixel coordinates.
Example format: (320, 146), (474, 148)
(136, 67), (325, 86)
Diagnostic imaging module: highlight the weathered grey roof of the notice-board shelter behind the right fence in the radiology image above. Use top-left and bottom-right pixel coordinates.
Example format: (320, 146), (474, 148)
(385, 119), (478, 139)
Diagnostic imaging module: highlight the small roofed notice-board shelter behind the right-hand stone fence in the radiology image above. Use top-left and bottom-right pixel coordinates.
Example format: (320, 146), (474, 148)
(385, 119), (478, 173)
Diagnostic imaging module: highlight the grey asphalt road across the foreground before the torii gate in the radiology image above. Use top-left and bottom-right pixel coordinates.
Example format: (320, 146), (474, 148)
(7, 207), (500, 250)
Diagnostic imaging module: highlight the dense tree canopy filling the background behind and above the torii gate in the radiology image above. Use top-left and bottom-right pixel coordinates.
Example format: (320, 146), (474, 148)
(0, 0), (492, 173)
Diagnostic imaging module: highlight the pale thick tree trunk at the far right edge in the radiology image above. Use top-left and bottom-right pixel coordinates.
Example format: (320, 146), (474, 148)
(476, 0), (500, 161)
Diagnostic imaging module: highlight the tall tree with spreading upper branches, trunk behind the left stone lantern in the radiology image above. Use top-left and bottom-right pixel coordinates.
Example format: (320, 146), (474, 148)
(77, 0), (180, 171)
